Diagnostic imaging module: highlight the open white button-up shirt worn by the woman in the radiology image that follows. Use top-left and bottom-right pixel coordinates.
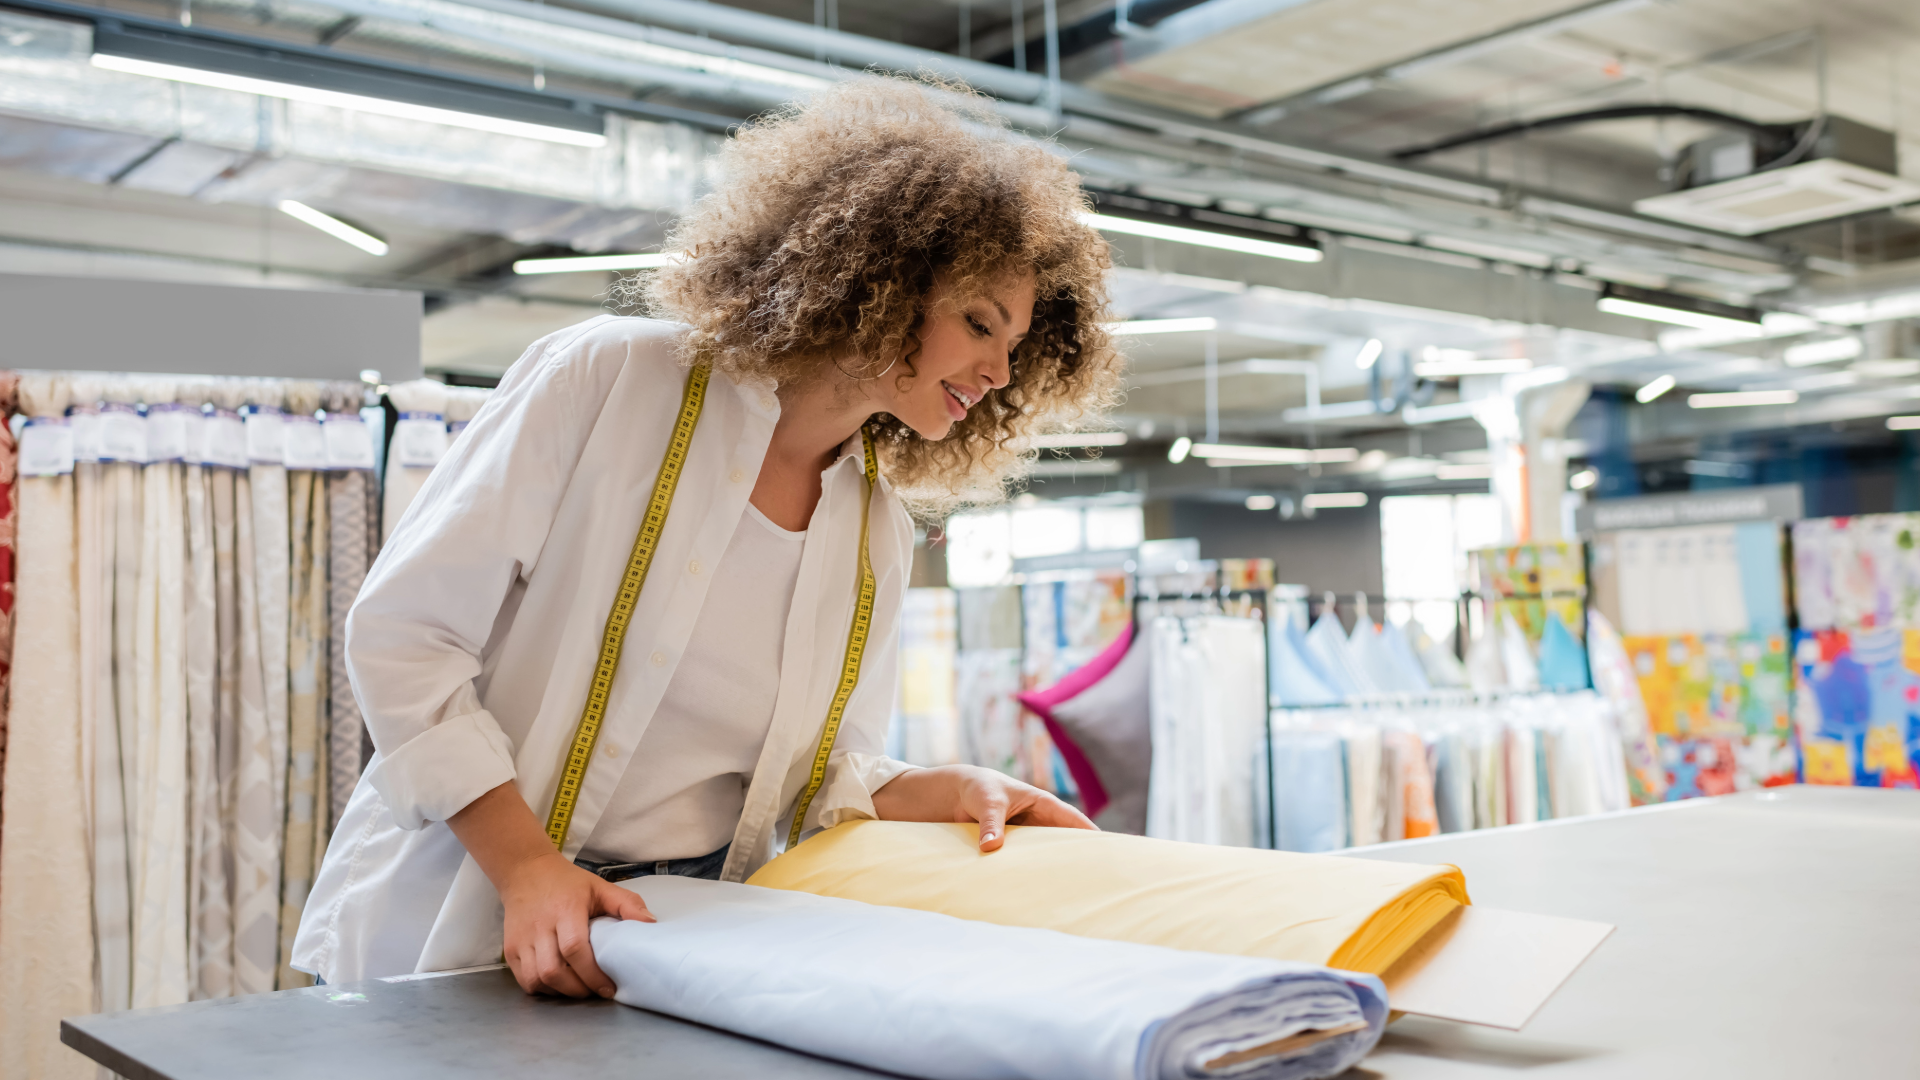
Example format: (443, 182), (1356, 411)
(292, 315), (914, 982)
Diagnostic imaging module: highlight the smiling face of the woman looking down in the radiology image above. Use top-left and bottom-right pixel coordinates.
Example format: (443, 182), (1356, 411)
(872, 271), (1035, 440)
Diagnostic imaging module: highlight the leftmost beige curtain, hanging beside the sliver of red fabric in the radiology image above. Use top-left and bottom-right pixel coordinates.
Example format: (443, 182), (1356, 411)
(0, 375), (94, 1080)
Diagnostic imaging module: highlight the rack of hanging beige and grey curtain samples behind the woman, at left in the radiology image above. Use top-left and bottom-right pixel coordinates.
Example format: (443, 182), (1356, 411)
(0, 373), (486, 1076)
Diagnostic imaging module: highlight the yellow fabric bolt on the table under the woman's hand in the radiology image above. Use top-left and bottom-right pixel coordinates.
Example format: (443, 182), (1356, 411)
(747, 821), (1471, 974)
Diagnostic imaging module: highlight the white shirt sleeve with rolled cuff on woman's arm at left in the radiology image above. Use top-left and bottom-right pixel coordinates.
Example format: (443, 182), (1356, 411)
(346, 323), (605, 828)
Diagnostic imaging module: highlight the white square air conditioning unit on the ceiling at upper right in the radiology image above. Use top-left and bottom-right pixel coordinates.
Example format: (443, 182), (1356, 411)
(1634, 117), (1920, 236)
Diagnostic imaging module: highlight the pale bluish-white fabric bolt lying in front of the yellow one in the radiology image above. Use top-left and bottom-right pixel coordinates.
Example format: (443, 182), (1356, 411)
(591, 876), (1386, 1080)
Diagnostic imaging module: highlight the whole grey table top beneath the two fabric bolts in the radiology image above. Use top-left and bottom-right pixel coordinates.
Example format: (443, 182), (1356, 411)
(61, 788), (1920, 1080)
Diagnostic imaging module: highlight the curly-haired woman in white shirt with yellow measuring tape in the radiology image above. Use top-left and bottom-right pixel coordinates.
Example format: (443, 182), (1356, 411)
(289, 81), (1117, 997)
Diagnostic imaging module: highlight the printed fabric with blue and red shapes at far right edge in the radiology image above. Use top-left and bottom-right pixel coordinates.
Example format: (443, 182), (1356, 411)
(1793, 628), (1920, 788)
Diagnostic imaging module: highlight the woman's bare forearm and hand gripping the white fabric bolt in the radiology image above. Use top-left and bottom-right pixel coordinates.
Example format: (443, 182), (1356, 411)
(447, 780), (655, 997)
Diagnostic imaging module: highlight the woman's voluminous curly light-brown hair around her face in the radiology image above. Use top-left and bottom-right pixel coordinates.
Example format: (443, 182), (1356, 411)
(636, 79), (1121, 521)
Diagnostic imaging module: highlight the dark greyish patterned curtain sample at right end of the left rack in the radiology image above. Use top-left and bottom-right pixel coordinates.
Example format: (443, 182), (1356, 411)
(323, 382), (372, 822)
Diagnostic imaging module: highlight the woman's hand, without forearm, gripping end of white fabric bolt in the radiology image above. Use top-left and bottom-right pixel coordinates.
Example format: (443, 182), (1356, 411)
(499, 849), (655, 997)
